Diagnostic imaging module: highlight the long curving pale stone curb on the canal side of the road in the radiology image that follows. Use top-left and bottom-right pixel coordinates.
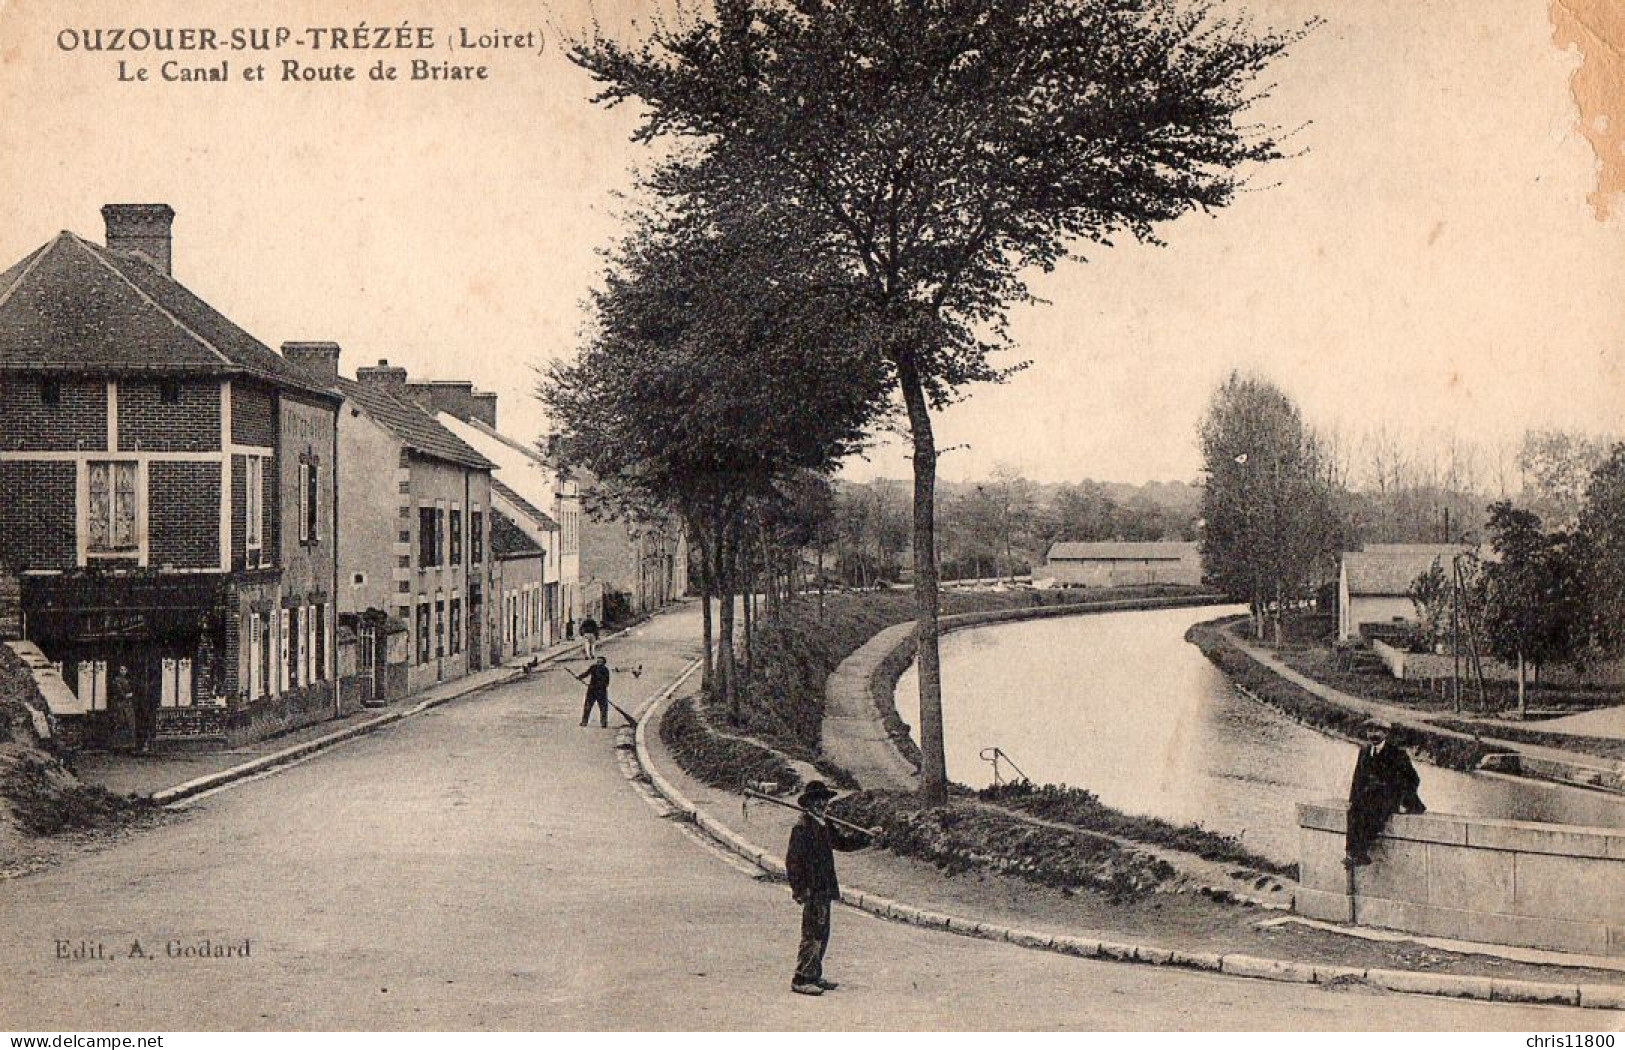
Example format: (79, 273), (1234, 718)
(634, 660), (1625, 1009)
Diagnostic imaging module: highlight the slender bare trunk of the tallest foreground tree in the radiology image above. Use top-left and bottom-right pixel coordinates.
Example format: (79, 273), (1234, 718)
(897, 358), (947, 806)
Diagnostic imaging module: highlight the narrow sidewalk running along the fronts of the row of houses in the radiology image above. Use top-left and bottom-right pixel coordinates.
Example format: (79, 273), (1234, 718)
(73, 636), (598, 803)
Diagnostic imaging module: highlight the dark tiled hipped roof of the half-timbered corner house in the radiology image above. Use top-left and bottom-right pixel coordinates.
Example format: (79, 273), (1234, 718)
(0, 231), (332, 397)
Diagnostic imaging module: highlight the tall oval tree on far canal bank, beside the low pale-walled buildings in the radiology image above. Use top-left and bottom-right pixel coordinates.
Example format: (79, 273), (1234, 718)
(1201, 372), (1342, 644)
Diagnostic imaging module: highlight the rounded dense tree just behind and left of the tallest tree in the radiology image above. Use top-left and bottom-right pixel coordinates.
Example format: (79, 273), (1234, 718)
(538, 213), (886, 710)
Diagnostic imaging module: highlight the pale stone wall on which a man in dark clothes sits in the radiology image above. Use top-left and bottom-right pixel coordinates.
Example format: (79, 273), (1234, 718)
(1294, 801), (1625, 956)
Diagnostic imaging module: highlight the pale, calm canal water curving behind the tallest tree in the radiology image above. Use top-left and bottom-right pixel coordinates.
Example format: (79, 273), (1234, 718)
(895, 606), (1625, 863)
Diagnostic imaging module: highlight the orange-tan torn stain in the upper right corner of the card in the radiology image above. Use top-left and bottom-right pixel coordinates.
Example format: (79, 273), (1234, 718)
(1552, 0), (1625, 219)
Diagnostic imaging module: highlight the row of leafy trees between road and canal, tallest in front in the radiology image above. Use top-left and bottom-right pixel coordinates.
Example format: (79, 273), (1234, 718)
(543, 0), (1319, 805)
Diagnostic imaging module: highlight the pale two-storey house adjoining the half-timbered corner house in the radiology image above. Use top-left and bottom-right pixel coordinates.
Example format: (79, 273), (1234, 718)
(283, 343), (496, 702)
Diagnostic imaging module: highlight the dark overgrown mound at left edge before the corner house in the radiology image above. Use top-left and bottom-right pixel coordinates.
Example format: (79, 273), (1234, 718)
(0, 645), (150, 860)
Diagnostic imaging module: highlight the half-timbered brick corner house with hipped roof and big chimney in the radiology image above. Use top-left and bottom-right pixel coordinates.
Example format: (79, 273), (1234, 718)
(0, 205), (341, 744)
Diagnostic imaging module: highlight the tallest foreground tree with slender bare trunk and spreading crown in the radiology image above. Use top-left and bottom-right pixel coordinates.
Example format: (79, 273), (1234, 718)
(572, 0), (1298, 805)
